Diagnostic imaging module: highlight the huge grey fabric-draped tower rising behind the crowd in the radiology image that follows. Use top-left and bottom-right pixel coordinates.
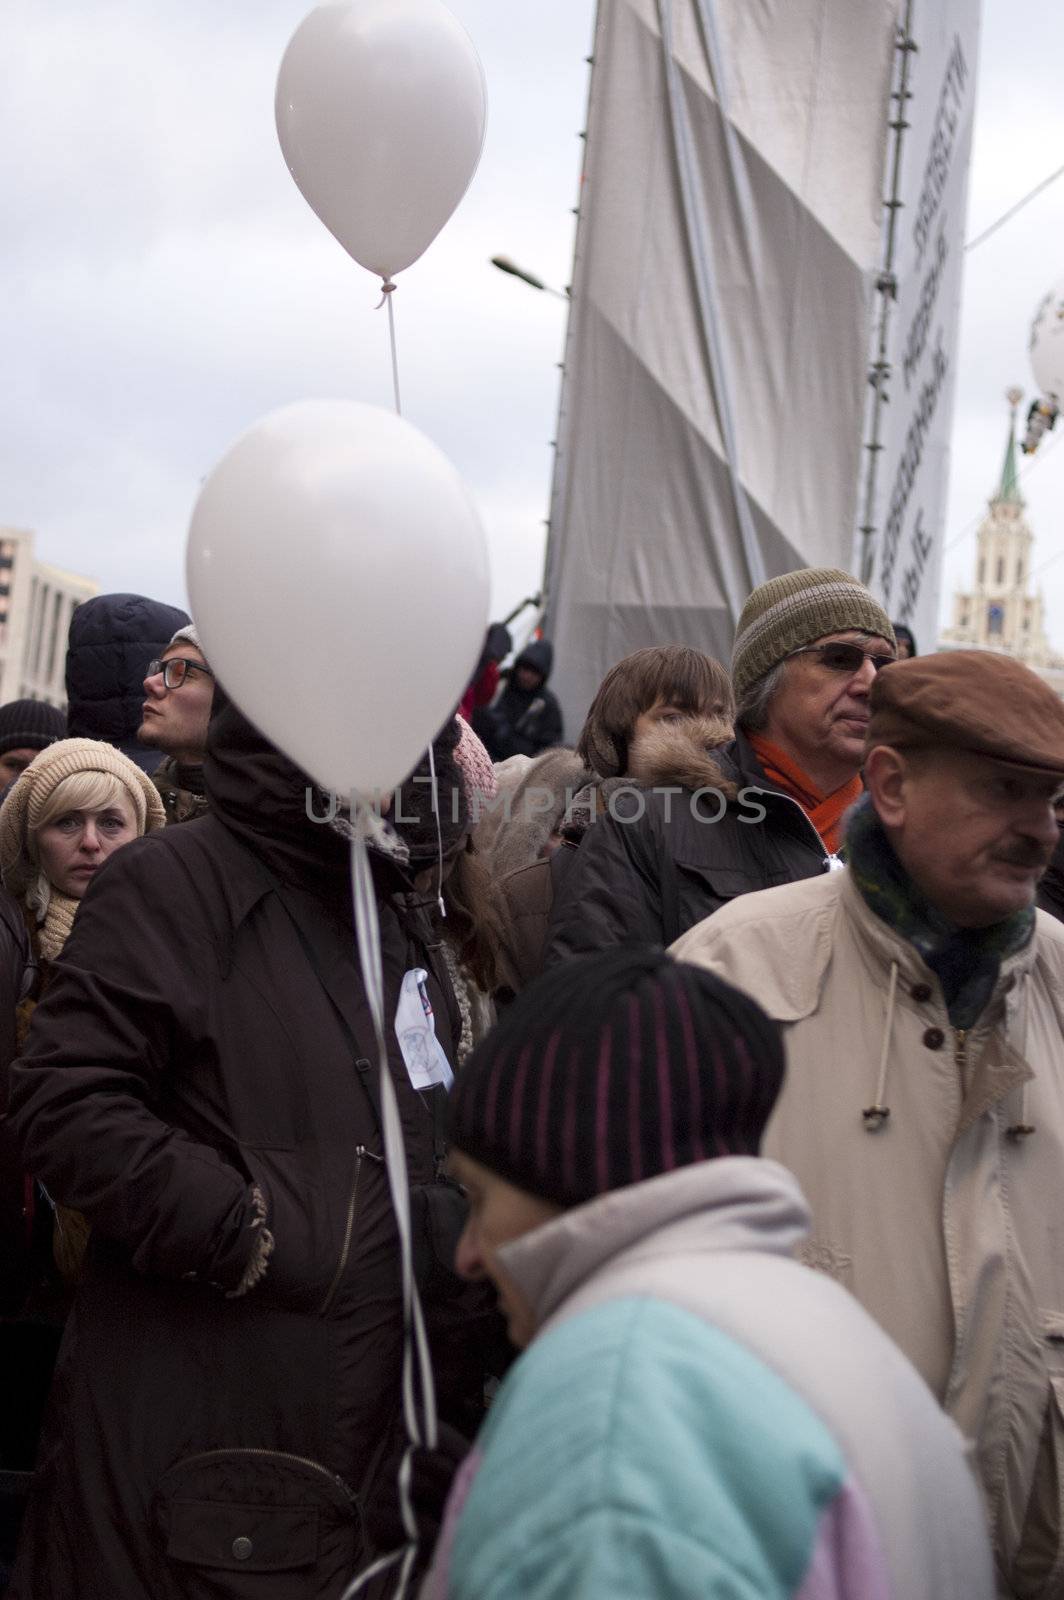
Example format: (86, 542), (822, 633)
(546, 0), (978, 730)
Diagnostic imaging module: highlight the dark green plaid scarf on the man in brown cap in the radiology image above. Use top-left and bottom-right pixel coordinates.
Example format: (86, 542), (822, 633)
(846, 795), (1035, 1029)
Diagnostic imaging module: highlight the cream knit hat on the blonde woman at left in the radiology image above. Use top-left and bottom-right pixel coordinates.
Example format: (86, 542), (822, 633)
(0, 739), (166, 894)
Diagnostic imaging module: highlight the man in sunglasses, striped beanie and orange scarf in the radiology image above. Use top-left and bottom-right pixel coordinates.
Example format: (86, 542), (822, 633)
(547, 568), (894, 965)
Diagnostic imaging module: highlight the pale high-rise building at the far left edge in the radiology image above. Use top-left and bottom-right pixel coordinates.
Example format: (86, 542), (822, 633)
(0, 528), (99, 707)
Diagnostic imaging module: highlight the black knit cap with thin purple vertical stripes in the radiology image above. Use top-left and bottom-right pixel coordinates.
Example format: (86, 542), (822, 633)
(450, 946), (784, 1206)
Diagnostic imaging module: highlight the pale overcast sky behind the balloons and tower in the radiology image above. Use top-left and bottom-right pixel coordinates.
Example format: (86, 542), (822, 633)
(0, 0), (1064, 648)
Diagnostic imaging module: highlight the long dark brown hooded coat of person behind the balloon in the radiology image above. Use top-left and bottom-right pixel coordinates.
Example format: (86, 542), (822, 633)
(11, 707), (458, 1600)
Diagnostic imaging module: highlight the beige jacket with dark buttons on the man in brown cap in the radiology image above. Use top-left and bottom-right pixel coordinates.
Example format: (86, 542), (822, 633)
(672, 870), (1064, 1600)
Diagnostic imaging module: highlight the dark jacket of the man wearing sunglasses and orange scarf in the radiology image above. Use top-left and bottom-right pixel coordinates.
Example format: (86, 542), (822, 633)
(544, 731), (827, 966)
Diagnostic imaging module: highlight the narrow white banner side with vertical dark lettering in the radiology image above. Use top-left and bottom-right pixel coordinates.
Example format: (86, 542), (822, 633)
(854, 0), (979, 650)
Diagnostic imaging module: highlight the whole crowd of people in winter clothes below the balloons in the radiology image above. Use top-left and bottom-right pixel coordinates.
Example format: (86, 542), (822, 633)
(0, 568), (1064, 1600)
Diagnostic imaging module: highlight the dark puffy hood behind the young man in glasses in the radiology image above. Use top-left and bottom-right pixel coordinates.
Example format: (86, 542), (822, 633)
(67, 595), (189, 773)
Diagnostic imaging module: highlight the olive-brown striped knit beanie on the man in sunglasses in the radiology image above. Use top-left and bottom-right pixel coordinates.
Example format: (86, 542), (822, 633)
(731, 566), (894, 701)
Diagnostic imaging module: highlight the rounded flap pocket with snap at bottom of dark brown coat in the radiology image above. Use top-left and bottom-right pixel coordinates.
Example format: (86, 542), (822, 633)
(154, 1448), (362, 1600)
